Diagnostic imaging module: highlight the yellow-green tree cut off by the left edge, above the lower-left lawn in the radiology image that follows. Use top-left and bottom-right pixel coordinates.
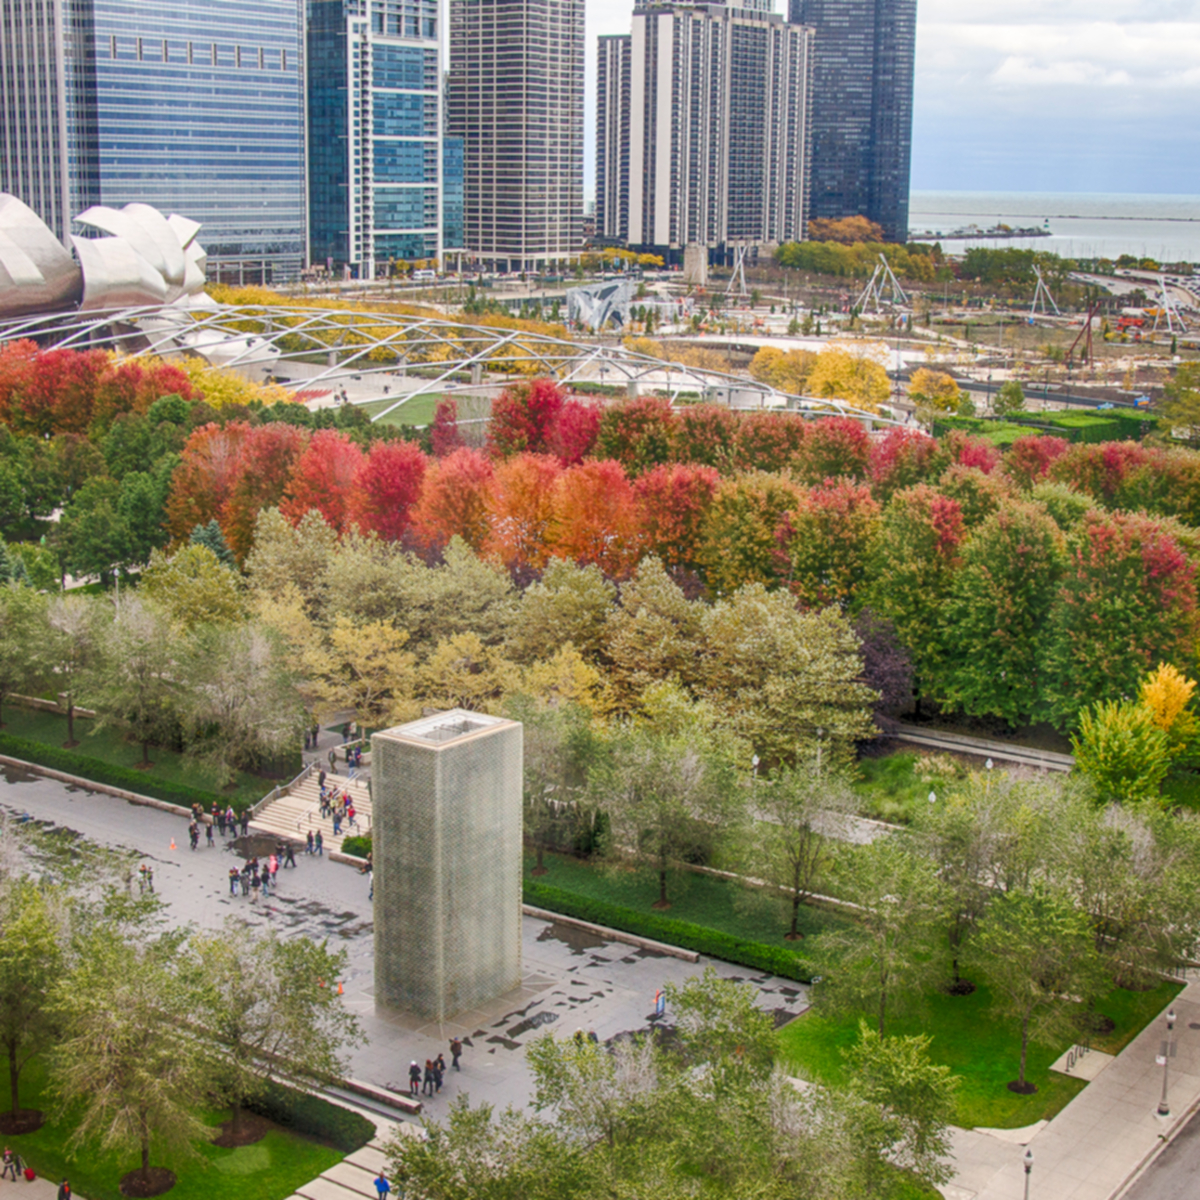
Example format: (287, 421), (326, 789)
(0, 878), (65, 1122)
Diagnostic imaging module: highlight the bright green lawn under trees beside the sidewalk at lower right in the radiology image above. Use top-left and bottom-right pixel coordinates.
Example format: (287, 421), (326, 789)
(780, 983), (1182, 1129)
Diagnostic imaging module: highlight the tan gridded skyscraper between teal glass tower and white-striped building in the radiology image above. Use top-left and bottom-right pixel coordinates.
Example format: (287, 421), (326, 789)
(446, 0), (583, 271)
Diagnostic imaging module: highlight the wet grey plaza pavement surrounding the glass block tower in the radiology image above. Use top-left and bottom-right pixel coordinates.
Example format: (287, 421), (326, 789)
(0, 768), (806, 1116)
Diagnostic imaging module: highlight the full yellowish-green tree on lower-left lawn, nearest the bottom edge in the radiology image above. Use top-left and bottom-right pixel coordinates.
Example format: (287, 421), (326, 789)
(50, 930), (211, 1192)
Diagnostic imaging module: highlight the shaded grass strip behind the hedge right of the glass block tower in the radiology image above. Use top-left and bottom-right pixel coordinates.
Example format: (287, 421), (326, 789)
(524, 853), (844, 953)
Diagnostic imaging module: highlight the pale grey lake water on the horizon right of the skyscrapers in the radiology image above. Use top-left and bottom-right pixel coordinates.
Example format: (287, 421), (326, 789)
(908, 191), (1200, 263)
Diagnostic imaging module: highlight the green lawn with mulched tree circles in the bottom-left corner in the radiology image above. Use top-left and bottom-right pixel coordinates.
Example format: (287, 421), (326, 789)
(0, 1058), (346, 1200)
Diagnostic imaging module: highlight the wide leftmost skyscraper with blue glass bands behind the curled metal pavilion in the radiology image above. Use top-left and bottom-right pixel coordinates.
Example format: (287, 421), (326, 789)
(0, 0), (307, 282)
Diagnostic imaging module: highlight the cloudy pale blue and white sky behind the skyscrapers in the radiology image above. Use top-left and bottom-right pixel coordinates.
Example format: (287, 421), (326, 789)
(587, 0), (1200, 196)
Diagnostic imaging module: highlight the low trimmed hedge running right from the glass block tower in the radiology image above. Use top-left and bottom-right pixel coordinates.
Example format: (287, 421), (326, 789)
(524, 880), (811, 983)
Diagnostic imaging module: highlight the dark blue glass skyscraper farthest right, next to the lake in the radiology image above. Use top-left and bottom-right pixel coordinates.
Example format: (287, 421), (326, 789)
(790, 0), (917, 241)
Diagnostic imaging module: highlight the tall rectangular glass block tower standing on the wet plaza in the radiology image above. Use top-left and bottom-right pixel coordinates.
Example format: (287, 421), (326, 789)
(371, 708), (523, 1020)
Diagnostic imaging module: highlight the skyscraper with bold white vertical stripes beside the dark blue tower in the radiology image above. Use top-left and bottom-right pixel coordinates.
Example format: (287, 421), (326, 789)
(596, 2), (811, 258)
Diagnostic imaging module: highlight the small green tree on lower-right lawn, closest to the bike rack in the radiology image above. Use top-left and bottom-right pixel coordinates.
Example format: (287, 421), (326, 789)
(976, 882), (1106, 1094)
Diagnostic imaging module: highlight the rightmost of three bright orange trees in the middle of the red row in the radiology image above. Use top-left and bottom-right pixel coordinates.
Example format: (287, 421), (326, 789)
(548, 460), (638, 576)
